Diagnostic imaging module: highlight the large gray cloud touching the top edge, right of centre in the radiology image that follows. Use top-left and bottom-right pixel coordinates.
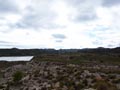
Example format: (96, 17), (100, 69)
(66, 0), (100, 22)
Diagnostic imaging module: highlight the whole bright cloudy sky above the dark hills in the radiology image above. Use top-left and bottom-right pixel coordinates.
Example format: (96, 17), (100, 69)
(0, 0), (120, 49)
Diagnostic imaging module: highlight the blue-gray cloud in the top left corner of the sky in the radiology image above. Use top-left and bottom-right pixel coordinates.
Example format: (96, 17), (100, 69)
(0, 0), (18, 13)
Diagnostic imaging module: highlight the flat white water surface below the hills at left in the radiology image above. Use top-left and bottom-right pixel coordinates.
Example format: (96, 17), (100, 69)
(0, 56), (34, 61)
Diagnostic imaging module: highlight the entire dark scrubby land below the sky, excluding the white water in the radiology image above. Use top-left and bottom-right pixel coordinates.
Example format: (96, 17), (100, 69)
(0, 48), (120, 90)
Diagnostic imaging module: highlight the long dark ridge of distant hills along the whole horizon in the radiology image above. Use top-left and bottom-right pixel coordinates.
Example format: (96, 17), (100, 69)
(0, 47), (120, 56)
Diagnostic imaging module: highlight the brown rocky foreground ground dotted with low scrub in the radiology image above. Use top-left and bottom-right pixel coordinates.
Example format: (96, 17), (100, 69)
(0, 61), (120, 90)
